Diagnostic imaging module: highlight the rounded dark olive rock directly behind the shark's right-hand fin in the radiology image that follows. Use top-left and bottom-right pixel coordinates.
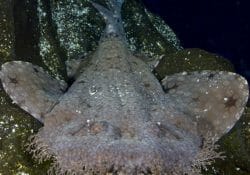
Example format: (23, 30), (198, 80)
(154, 48), (234, 80)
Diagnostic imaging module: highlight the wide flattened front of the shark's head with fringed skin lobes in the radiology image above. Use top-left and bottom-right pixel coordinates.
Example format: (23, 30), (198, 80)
(29, 115), (199, 174)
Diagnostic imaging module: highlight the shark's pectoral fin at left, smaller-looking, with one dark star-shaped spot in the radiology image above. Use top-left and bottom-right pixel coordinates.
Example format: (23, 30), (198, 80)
(0, 61), (67, 122)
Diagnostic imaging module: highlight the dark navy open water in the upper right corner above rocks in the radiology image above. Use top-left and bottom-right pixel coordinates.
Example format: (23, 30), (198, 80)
(143, 0), (250, 82)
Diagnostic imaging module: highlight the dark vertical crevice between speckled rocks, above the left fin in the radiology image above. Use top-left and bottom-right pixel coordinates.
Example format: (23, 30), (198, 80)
(13, 0), (42, 66)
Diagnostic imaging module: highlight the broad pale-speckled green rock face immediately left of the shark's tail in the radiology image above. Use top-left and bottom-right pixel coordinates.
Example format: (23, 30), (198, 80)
(51, 0), (105, 59)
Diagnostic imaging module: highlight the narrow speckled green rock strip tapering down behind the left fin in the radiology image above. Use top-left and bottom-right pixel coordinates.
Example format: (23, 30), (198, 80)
(37, 0), (67, 81)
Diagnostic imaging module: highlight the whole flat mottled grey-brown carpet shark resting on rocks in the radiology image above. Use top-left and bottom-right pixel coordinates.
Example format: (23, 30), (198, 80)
(0, 0), (248, 175)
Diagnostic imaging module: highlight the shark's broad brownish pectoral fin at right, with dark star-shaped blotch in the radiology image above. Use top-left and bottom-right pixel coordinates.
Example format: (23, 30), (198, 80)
(162, 71), (248, 138)
